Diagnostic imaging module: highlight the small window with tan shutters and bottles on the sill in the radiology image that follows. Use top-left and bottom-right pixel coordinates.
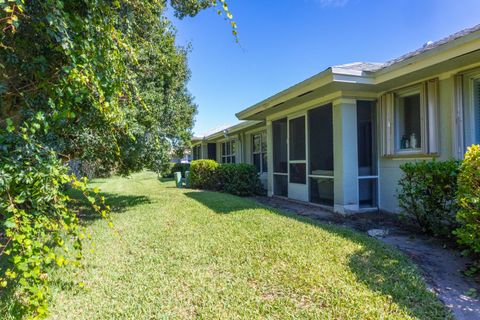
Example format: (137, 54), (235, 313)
(379, 79), (439, 156)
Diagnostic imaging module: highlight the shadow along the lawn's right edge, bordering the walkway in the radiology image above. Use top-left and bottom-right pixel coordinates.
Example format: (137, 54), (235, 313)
(185, 191), (448, 319)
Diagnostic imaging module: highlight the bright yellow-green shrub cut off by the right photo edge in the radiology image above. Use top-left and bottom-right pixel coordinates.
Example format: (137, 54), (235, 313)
(454, 145), (480, 254)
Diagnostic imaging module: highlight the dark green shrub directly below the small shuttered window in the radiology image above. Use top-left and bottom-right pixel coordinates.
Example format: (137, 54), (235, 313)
(397, 160), (459, 236)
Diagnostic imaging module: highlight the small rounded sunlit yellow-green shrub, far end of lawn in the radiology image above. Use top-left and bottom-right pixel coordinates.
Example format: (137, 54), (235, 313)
(190, 159), (219, 190)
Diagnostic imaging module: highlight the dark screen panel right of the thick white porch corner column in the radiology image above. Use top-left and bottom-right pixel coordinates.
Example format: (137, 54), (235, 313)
(357, 100), (378, 208)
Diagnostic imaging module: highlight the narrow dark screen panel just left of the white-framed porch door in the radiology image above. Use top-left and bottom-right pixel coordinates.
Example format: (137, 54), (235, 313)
(272, 118), (288, 197)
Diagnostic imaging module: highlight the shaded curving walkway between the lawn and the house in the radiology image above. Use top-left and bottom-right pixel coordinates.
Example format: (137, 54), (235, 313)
(254, 197), (480, 320)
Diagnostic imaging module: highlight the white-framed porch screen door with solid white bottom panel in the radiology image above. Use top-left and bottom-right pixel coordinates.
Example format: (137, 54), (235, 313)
(288, 115), (308, 201)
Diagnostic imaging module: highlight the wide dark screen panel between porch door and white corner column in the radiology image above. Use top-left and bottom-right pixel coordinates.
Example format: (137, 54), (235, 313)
(308, 104), (334, 206)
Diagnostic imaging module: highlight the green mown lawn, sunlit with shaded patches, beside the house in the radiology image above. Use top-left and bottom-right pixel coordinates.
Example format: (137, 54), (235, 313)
(16, 172), (449, 319)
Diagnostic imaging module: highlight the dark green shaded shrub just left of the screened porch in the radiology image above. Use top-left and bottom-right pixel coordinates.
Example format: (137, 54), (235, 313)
(217, 163), (263, 197)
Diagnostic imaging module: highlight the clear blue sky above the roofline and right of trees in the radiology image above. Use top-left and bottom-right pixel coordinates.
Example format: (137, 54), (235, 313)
(170, 0), (480, 135)
